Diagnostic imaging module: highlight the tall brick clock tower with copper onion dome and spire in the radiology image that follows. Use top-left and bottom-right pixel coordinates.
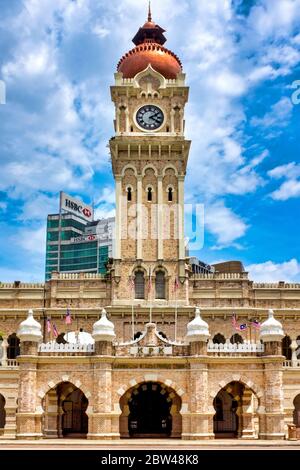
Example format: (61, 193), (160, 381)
(110, 8), (190, 307)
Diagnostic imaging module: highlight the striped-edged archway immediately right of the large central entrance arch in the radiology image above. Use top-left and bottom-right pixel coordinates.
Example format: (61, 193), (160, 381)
(210, 375), (263, 438)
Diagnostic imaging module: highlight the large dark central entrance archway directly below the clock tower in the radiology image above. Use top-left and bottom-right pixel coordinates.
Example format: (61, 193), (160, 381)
(120, 382), (182, 438)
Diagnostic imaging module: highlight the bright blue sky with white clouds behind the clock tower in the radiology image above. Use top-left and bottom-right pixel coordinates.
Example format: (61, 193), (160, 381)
(0, 0), (300, 282)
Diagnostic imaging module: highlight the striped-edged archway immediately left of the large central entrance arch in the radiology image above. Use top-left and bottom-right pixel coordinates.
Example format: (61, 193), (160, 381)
(39, 376), (91, 438)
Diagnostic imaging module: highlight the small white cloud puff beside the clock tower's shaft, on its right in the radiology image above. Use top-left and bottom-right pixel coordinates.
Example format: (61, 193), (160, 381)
(205, 202), (248, 249)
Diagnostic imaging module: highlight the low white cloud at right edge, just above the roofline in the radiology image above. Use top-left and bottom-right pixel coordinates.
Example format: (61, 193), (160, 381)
(246, 259), (300, 282)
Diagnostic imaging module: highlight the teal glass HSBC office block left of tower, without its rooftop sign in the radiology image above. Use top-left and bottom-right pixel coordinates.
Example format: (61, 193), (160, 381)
(45, 196), (115, 280)
